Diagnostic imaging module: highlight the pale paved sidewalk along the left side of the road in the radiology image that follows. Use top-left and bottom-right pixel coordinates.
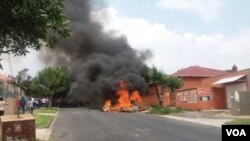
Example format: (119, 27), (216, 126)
(36, 112), (58, 141)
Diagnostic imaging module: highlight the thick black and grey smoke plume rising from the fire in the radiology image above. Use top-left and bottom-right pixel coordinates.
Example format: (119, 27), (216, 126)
(44, 0), (149, 104)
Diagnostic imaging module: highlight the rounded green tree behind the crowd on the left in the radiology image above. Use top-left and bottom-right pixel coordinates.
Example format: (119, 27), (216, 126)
(31, 67), (70, 104)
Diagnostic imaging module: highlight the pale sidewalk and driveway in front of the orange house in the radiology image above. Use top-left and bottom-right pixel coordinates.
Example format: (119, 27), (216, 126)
(160, 110), (250, 128)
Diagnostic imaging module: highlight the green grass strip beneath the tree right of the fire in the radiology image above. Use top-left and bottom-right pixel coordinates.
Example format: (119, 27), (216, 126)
(149, 106), (182, 115)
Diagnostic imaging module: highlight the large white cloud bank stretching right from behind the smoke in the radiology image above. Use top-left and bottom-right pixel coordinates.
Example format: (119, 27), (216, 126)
(92, 8), (250, 73)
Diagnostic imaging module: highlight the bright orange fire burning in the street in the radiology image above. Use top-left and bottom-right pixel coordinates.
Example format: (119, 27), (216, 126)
(102, 80), (142, 112)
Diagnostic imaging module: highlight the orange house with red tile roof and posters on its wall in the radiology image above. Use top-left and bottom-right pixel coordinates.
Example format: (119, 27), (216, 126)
(172, 66), (250, 110)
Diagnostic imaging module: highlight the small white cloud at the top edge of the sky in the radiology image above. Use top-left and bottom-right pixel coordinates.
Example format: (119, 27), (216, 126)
(157, 0), (223, 21)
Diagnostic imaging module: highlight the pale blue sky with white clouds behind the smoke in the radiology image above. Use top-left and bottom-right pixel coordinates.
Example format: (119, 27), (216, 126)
(1, 0), (250, 75)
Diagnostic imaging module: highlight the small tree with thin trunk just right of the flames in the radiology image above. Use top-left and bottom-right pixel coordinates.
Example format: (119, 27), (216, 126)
(141, 66), (182, 106)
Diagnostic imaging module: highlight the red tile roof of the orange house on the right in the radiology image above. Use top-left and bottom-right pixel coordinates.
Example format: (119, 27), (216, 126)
(172, 66), (228, 77)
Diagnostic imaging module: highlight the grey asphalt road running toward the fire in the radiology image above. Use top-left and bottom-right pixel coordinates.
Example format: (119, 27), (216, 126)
(50, 109), (221, 141)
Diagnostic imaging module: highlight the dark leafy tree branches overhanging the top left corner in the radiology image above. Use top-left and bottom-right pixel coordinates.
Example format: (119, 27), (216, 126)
(0, 0), (69, 55)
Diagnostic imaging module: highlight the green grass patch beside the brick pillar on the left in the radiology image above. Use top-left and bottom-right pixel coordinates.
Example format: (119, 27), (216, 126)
(35, 114), (54, 128)
